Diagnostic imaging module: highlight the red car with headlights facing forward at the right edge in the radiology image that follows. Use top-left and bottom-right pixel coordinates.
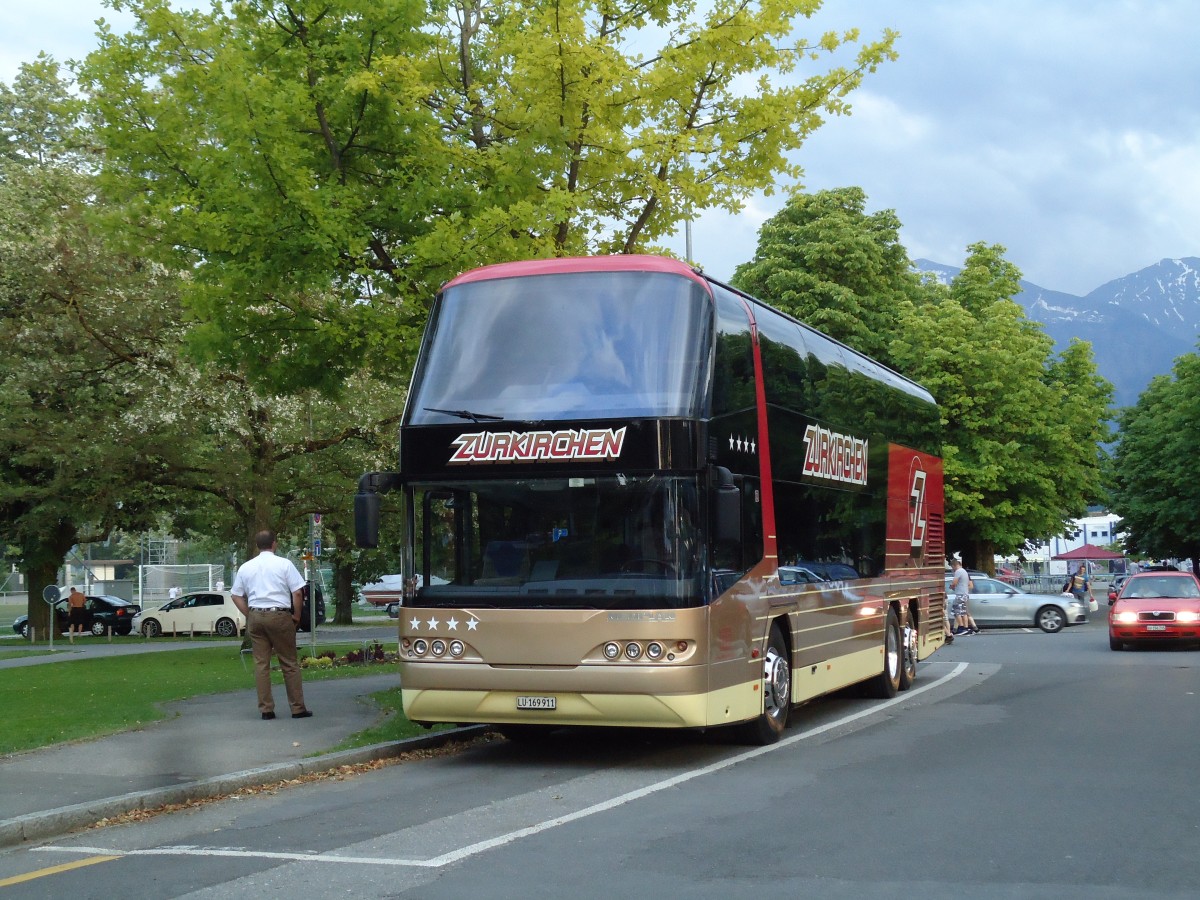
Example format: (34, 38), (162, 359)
(1109, 572), (1200, 650)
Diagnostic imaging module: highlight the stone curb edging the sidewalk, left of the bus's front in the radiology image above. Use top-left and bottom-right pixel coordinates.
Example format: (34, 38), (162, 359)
(0, 725), (488, 847)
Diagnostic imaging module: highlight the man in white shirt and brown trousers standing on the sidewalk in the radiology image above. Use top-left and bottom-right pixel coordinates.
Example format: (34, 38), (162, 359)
(230, 530), (312, 719)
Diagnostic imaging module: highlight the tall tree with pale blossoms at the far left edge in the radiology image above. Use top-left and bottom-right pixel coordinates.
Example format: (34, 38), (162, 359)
(0, 58), (178, 629)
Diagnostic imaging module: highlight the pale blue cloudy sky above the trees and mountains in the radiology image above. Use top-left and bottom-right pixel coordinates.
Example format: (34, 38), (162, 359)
(0, 0), (1200, 295)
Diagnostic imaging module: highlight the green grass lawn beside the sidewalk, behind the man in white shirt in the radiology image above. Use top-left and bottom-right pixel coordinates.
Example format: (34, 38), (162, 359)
(0, 642), (425, 754)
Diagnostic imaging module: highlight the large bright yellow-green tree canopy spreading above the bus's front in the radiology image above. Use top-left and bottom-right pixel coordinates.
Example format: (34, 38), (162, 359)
(84, 0), (895, 392)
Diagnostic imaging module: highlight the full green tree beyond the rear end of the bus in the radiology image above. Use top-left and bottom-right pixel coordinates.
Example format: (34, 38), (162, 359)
(893, 244), (1112, 570)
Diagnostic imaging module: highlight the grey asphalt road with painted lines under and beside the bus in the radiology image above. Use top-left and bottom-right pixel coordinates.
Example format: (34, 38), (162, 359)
(0, 601), (1200, 900)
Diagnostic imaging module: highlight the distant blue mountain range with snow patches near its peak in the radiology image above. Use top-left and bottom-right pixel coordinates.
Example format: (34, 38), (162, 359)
(914, 257), (1200, 407)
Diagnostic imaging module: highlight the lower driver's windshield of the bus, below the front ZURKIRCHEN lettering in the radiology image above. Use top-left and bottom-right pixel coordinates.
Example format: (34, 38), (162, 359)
(404, 475), (704, 610)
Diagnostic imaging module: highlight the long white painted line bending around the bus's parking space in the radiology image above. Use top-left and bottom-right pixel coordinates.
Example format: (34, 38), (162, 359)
(32, 662), (968, 869)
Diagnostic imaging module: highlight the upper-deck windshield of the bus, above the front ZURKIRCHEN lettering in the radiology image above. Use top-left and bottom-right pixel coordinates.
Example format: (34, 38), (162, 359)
(406, 271), (712, 425)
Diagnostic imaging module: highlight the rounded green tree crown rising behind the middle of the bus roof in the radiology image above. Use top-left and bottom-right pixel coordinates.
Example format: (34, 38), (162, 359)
(732, 187), (922, 364)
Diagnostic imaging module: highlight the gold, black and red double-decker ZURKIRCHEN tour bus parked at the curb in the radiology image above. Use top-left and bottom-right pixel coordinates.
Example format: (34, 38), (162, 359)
(355, 256), (944, 743)
